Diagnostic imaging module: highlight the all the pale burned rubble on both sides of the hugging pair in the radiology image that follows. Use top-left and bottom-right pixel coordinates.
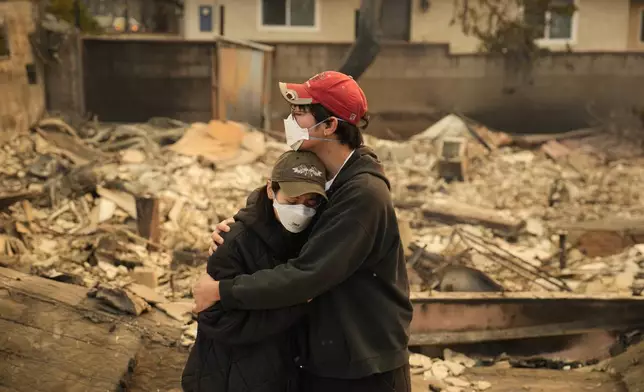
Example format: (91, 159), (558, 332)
(0, 115), (644, 391)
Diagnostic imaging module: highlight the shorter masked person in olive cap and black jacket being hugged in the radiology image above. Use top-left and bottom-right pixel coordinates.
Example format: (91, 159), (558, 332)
(181, 151), (326, 392)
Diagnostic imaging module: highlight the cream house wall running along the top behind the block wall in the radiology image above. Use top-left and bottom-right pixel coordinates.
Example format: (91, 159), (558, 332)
(184, 0), (644, 53)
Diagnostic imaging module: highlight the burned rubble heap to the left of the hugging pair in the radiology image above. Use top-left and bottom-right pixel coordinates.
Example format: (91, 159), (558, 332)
(0, 118), (285, 338)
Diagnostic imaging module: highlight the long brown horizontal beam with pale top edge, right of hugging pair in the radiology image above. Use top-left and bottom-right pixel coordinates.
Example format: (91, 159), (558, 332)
(410, 292), (644, 345)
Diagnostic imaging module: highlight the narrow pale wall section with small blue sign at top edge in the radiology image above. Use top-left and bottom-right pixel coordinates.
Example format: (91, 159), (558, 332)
(183, 0), (221, 40)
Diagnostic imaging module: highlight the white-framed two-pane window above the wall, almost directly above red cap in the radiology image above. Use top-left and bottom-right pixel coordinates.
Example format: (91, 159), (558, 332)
(261, 0), (317, 27)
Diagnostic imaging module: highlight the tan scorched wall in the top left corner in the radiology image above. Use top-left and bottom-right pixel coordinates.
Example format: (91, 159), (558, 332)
(0, 1), (45, 134)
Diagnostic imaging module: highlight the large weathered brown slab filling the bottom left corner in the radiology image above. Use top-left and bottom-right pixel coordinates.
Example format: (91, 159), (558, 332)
(0, 268), (187, 392)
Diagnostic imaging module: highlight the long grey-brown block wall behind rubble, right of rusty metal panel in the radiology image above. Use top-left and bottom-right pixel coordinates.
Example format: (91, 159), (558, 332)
(272, 43), (644, 135)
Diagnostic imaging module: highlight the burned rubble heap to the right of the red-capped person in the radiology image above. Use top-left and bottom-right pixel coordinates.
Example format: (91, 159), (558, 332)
(367, 115), (644, 294)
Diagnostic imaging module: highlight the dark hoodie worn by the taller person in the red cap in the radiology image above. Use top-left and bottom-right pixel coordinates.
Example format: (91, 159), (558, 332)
(220, 148), (412, 379)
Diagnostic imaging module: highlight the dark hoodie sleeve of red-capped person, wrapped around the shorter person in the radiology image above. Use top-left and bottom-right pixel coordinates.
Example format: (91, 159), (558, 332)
(219, 186), (384, 309)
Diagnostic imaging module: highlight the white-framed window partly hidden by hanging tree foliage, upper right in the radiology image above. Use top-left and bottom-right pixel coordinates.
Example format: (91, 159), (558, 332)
(524, 0), (577, 41)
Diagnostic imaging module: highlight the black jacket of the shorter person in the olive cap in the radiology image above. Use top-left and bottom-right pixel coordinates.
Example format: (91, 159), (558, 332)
(181, 190), (308, 392)
